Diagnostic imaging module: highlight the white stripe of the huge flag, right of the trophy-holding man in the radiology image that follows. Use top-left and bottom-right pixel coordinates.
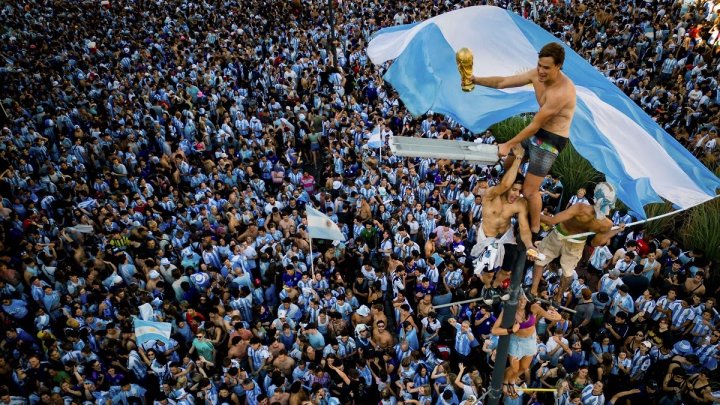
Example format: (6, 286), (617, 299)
(576, 87), (711, 207)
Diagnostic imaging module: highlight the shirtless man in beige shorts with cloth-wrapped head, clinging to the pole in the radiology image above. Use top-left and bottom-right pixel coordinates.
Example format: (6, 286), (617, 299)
(530, 182), (625, 296)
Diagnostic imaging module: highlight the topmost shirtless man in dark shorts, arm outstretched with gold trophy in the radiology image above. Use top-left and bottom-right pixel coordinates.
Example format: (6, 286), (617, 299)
(472, 42), (575, 233)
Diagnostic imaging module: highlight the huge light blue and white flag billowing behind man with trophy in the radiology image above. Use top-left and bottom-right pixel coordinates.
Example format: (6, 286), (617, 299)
(367, 6), (720, 217)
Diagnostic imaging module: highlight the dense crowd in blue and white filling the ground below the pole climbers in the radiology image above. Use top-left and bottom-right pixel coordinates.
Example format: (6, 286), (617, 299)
(0, 0), (720, 405)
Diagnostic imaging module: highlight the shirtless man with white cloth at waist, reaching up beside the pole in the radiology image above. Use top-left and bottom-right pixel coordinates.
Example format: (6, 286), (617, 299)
(470, 145), (533, 298)
